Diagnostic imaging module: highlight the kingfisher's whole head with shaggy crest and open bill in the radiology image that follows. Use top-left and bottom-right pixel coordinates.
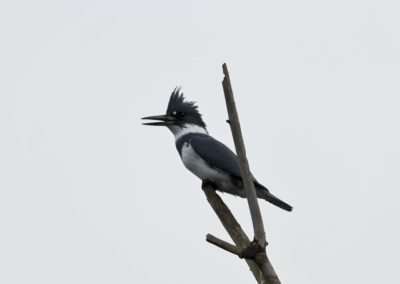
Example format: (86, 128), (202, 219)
(142, 88), (207, 138)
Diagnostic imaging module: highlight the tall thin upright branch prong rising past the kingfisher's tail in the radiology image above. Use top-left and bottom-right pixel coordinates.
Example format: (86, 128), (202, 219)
(222, 63), (266, 247)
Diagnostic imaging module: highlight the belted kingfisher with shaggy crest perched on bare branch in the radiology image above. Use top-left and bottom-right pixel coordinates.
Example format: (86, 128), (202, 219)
(142, 88), (292, 211)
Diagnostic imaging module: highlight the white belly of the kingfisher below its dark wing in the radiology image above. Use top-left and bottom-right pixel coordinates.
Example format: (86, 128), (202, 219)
(181, 143), (229, 183)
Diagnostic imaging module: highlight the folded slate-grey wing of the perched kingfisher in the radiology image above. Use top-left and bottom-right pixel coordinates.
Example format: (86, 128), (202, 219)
(190, 135), (241, 179)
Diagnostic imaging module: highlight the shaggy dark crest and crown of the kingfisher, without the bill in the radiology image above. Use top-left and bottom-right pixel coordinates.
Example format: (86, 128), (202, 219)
(166, 87), (206, 128)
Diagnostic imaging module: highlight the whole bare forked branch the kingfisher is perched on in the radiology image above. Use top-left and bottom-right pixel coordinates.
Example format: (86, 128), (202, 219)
(203, 64), (281, 284)
